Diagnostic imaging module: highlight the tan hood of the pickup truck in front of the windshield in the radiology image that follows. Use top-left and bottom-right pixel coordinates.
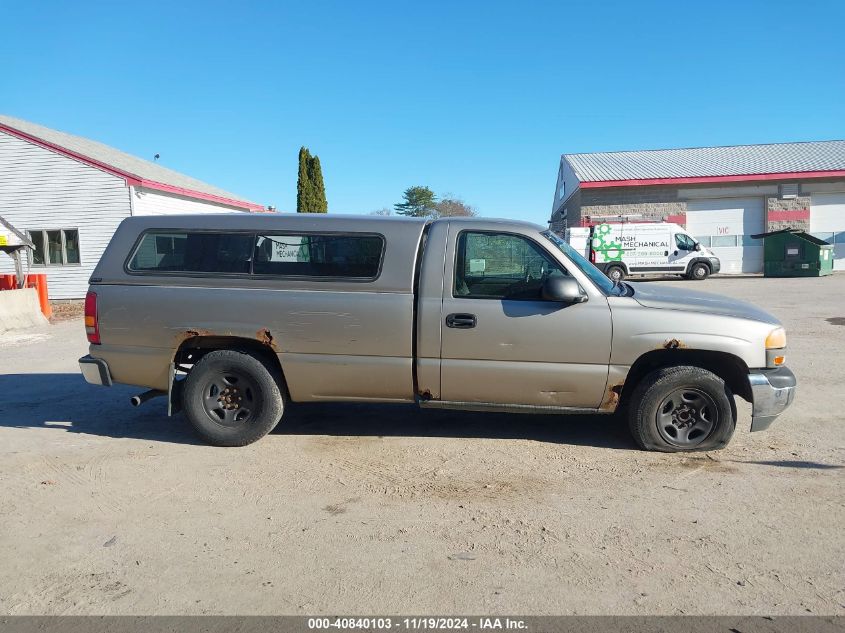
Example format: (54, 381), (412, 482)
(631, 282), (780, 325)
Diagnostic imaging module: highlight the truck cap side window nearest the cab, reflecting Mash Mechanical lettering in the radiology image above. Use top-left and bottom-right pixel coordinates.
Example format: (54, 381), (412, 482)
(253, 234), (384, 279)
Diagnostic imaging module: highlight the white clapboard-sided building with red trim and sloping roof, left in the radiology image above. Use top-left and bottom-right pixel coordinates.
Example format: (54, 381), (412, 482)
(0, 115), (264, 299)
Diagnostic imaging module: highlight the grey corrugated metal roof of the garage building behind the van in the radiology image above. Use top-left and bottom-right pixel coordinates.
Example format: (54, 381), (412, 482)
(563, 141), (845, 184)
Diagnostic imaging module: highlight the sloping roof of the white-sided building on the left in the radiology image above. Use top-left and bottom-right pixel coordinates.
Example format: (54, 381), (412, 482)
(0, 114), (263, 209)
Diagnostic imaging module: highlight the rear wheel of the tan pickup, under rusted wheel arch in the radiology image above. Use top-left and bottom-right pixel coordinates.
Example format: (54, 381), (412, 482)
(182, 350), (285, 446)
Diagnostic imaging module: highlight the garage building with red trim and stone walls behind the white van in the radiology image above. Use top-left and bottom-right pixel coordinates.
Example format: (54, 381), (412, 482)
(550, 141), (845, 273)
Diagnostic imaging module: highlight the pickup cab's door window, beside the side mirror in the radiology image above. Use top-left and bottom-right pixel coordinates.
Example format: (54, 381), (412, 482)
(453, 231), (568, 301)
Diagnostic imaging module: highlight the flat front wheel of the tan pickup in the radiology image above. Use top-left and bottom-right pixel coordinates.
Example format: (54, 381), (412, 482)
(628, 366), (736, 453)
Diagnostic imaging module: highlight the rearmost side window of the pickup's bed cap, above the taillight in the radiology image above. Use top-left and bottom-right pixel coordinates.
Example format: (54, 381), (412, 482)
(129, 231), (253, 273)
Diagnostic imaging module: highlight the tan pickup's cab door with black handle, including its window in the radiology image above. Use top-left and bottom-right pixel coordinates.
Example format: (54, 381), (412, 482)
(440, 223), (612, 408)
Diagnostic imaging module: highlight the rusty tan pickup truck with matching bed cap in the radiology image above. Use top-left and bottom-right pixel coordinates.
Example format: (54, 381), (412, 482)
(80, 214), (796, 451)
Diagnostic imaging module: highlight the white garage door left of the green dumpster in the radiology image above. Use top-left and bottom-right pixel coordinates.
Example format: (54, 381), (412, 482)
(687, 198), (766, 274)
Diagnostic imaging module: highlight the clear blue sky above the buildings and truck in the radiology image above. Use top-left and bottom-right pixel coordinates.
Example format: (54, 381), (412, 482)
(0, 0), (845, 223)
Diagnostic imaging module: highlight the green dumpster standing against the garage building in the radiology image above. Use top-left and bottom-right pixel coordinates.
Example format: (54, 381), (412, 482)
(751, 229), (833, 277)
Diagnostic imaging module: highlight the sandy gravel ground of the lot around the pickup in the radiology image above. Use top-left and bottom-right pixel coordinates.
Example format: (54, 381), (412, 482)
(0, 274), (845, 615)
